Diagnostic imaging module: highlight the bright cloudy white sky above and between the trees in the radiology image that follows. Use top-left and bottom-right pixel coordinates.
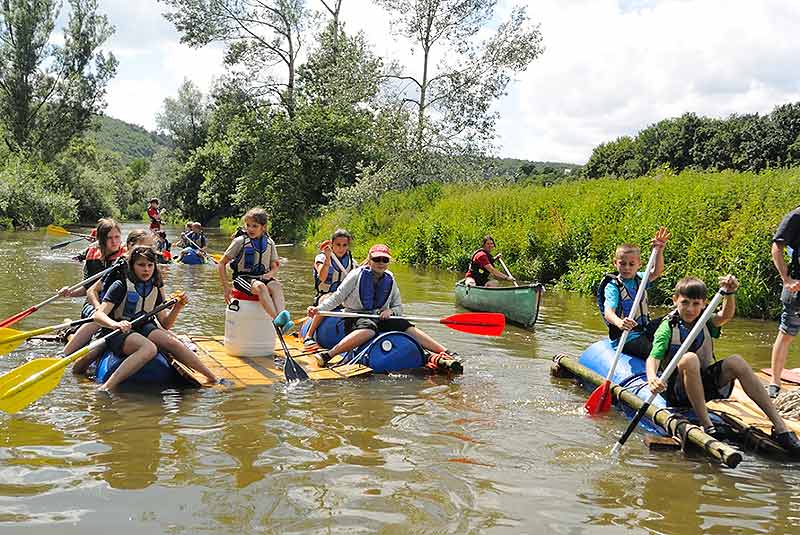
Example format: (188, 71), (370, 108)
(92, 0), (800, 163)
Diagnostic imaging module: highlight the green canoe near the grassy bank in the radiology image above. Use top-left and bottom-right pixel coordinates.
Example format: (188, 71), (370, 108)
(456, 280), (544, 327)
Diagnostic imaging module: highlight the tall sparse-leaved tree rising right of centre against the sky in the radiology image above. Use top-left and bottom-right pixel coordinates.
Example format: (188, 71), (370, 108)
(377, 0), (543, 153)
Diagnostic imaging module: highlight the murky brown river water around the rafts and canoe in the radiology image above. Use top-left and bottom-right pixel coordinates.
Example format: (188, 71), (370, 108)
(0, 225), (800, 535)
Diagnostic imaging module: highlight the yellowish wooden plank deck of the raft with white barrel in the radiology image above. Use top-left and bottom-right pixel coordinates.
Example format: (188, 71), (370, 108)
(187, 335), (372, 388)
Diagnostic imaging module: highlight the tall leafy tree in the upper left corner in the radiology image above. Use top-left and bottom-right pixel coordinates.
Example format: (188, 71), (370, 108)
(0, 0), (117, 159)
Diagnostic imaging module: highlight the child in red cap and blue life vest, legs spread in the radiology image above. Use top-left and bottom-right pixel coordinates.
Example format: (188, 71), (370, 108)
(308, 244), (461, 372)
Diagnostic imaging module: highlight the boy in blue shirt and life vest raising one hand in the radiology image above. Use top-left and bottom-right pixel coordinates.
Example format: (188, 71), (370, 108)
(597, 227), (670, 359)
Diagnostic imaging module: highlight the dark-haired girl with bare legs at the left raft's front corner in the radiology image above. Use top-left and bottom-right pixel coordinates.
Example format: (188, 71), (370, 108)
(94, 245), (219, 391)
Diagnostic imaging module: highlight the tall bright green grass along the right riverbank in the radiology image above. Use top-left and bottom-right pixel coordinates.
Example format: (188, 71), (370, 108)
(309, 169), (800, 317)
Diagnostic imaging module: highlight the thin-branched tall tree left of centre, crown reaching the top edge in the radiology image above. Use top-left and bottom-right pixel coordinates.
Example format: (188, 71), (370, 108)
(160, 0), (311, 117)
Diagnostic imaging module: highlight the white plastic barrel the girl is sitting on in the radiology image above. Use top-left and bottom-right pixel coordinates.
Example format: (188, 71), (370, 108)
(223, 290), (275, 357)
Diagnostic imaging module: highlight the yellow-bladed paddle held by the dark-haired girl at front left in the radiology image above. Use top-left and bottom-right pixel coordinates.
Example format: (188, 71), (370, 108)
(0, 297), (179, 414)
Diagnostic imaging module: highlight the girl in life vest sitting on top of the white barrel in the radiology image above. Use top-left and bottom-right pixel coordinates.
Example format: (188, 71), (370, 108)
(217, 207), (294, 332)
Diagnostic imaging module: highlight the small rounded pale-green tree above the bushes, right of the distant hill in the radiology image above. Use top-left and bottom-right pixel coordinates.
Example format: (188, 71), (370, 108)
(156, 80), (210, 159)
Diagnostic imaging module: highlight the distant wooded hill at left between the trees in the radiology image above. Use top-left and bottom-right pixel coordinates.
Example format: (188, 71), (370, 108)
(87, 115), (172, 162)
